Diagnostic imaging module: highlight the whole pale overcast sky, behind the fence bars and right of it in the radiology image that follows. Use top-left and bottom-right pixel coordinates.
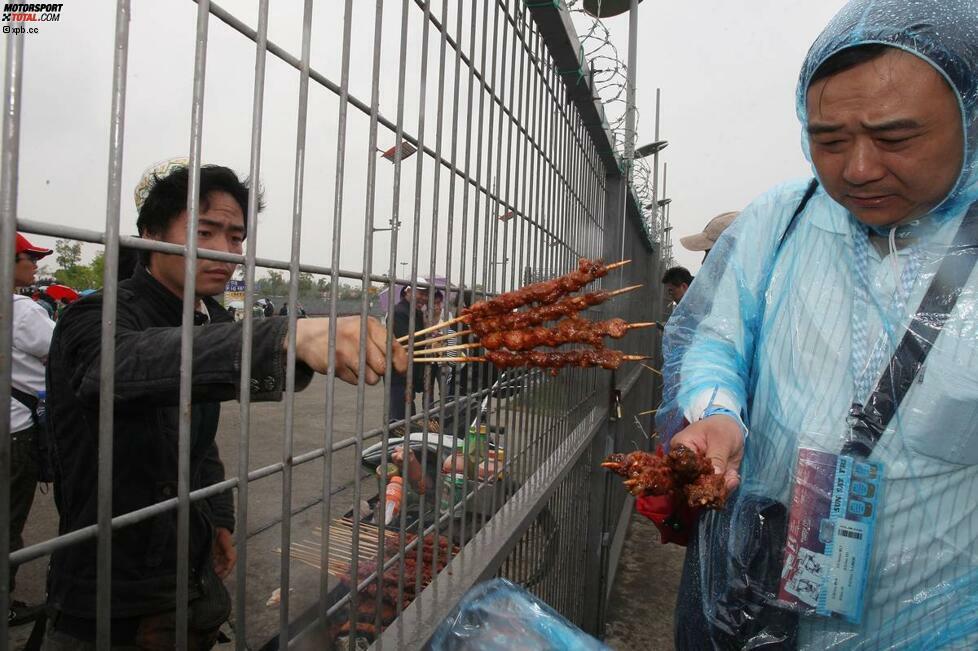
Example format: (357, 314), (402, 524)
(3, 0), (843, 284)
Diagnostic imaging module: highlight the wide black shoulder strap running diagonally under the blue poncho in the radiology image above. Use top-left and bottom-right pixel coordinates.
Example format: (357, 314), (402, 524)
(842, 203), (978, 457)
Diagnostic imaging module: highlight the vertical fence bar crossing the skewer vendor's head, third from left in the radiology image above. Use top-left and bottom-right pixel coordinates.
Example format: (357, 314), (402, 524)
(176, 0), (210, 649)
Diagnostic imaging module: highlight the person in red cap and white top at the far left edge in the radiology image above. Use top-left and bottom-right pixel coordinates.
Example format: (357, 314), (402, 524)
(7, 233), (54, 626)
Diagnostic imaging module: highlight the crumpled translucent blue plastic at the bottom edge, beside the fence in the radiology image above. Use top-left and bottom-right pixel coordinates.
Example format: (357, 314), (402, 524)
(430, 579), (610, 651)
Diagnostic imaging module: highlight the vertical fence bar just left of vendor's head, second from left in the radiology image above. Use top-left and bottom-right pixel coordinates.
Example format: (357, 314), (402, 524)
(95, 0), (129, 648)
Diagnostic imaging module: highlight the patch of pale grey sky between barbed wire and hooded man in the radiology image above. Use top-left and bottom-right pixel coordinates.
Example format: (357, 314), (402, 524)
(605, 0), (845, 271)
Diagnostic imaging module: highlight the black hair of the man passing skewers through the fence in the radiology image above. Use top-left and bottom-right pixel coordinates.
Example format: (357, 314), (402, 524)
(136, 165), (265, 237)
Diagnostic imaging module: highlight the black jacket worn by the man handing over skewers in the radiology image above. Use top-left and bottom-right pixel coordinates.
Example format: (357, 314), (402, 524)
(47, 266), (312, 617)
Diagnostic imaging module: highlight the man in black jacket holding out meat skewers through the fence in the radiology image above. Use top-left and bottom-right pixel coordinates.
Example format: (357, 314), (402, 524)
(45, 163), (406, 649)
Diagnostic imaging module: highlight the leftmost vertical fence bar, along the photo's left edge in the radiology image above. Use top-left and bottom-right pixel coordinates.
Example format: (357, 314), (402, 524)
(0, 23), (24, 640)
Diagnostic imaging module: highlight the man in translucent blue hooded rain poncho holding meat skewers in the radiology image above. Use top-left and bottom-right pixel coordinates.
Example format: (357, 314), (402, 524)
(658, 0), (978, 649)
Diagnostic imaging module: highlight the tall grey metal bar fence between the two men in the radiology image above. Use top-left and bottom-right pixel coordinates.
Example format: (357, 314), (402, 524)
(0, 0), (662, 649)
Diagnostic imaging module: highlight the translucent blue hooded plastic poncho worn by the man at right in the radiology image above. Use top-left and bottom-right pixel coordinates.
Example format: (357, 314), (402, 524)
(657, 0), (978, 649)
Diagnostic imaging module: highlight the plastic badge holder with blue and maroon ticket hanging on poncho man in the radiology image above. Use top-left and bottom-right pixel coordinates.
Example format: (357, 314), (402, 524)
(778, 448), (883, 624)
